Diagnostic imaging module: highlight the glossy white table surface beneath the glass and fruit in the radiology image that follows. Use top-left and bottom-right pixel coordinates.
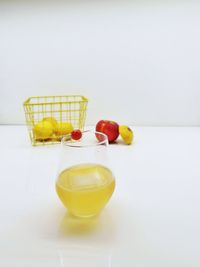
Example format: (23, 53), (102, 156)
(0, 126), (200, 267)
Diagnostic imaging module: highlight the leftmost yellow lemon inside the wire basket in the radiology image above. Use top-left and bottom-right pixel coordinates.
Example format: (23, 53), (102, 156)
(33, 121), (53, 140)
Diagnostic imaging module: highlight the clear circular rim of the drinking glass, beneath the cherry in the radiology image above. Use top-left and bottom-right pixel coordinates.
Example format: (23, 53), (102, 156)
(61, 130), (109, 148)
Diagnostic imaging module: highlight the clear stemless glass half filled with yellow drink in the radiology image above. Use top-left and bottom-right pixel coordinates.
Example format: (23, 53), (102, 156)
(56, 131), (115, 217)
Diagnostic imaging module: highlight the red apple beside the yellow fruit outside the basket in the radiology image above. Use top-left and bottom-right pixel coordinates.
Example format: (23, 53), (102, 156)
(96, 120), (119, 143)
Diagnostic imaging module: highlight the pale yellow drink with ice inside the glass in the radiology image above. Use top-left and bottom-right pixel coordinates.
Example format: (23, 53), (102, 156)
(56, 164), (115, 217)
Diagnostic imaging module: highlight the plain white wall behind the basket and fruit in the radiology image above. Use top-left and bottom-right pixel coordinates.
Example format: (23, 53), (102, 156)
(0, 1), (200, 125)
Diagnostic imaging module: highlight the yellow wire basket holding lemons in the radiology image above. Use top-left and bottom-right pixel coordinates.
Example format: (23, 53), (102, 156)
(23, 95), (88, 146)
